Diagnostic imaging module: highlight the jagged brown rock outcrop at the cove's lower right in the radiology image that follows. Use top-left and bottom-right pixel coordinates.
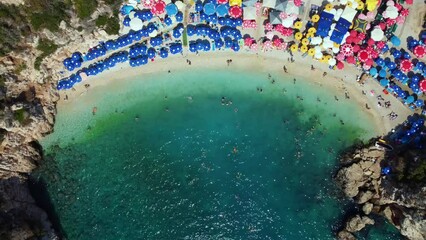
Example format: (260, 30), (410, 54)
(335, 143), (426, 240)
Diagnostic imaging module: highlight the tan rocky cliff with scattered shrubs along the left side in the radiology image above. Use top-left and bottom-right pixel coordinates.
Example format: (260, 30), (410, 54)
(0, 0), (119, 240)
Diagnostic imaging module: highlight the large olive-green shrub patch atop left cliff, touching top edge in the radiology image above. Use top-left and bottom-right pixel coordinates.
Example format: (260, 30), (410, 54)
(26, 0), (71, 32)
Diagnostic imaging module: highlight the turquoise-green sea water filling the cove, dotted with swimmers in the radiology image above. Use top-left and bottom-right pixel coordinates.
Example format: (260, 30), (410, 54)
(39, 70), (397, 239)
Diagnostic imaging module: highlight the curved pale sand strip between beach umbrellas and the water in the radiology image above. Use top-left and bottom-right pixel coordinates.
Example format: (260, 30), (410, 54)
(59, 48), (412, 135)
